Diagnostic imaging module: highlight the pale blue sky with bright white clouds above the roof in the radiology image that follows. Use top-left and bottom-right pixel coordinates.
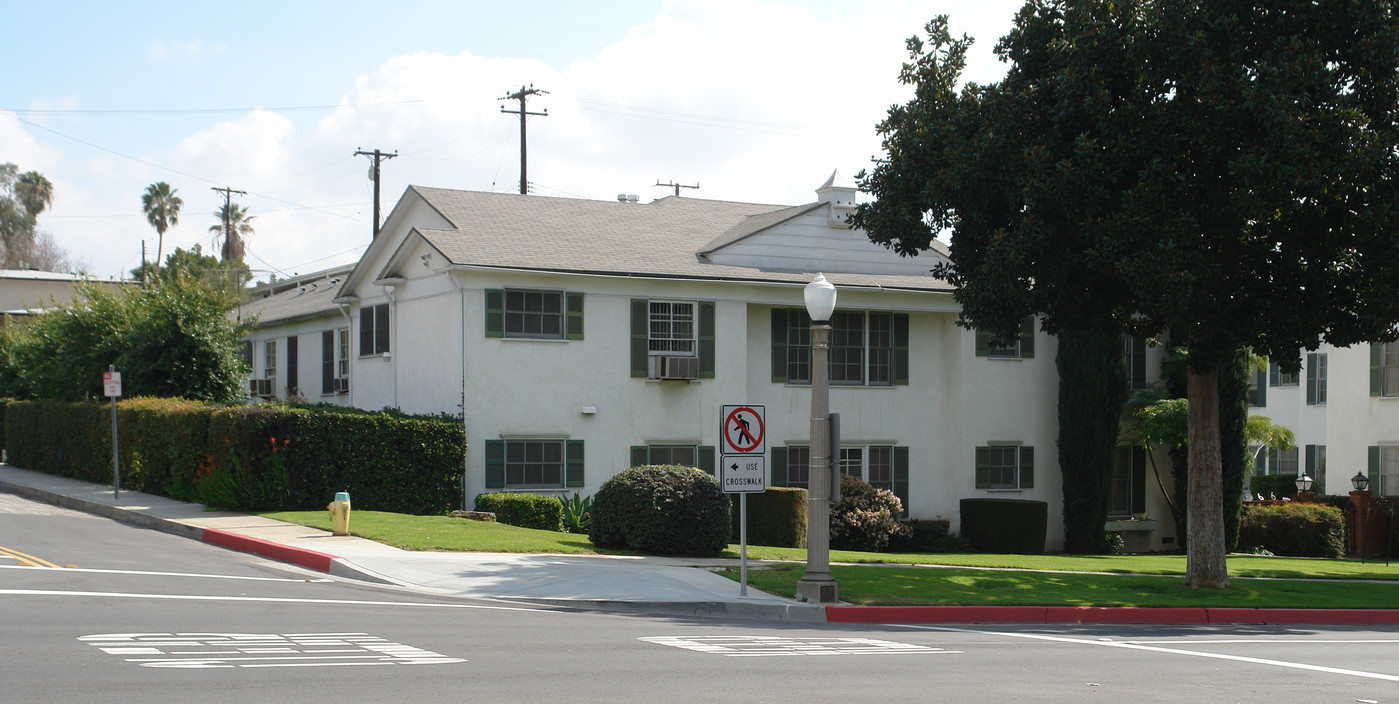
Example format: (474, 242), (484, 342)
(0, 0), (1020, 284)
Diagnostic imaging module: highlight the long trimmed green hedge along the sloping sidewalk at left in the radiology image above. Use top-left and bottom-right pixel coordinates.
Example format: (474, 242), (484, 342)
(4, 399), (466, 515)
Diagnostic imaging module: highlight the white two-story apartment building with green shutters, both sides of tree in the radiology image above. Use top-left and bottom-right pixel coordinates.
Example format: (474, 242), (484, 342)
(246, 172), (1382, 550)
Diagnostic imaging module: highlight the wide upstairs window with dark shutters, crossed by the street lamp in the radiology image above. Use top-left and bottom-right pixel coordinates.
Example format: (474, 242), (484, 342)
(772, 308), (908, 386)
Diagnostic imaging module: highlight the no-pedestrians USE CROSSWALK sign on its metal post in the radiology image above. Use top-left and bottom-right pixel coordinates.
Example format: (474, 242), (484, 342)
(719, 404), (768, 596)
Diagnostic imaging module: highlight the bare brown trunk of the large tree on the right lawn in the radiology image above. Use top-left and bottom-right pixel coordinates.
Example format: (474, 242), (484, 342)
(1185, 367), (1228, 589)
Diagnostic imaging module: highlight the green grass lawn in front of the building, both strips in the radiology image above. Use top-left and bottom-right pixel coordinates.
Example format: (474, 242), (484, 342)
(262, 511), (1399, 609)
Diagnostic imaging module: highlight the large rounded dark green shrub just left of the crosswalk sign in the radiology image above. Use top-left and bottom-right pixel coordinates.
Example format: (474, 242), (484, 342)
(588, 465), (729, 556)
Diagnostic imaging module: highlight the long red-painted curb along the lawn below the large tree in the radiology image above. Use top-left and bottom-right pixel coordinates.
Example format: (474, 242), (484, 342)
(825, 606), (1399, 626)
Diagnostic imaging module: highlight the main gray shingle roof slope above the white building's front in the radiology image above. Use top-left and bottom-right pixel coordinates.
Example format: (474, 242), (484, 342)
(411, 186), (950, 291)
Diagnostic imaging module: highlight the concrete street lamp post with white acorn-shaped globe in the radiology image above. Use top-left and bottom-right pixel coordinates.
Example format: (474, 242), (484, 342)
(796, 274), (841, 603)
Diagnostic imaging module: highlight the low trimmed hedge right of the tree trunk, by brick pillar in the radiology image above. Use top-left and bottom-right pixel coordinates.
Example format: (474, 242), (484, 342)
(1238, 501), (1346, 557)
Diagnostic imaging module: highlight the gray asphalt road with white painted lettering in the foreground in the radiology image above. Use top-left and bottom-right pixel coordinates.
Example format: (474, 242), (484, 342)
(0, 494), (1399, 704)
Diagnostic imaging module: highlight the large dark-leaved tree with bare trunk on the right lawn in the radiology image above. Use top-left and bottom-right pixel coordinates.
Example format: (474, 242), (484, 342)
(852, 0), (1399, 588)
